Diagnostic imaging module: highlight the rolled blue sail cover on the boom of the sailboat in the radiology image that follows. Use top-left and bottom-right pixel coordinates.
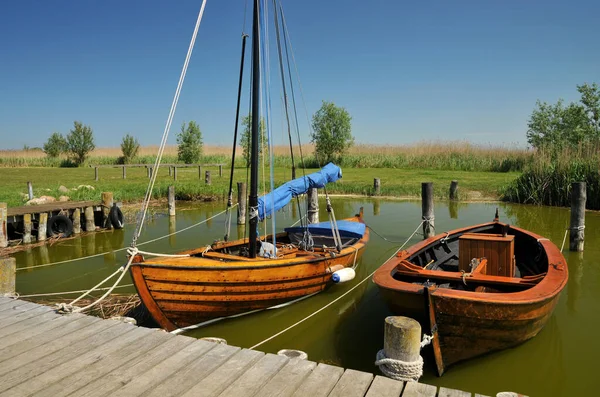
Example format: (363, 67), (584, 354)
(258, 163), (342, 220)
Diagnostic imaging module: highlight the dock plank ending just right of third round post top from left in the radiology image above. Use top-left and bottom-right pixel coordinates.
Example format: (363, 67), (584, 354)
(257, 358), (317, 397)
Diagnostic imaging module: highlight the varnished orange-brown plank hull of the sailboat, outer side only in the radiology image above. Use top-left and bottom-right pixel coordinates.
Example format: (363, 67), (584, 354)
(130, 218), (369, 331)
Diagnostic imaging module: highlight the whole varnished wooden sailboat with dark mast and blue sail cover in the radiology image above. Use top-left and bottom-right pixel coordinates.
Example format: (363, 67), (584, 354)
(130, 1), (369, 331)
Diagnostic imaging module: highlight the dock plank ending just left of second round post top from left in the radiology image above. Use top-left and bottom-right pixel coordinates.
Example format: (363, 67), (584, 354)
(111, 340), (216, 397)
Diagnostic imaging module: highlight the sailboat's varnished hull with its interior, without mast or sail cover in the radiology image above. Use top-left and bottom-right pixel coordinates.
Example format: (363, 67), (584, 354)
(130, 209), (369, 331)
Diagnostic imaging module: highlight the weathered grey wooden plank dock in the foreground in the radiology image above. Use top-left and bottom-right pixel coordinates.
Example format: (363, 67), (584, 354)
(0, 297), (500, 397)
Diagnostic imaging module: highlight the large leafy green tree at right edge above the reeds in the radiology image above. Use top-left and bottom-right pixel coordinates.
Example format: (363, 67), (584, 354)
(527, 83), (600, 149)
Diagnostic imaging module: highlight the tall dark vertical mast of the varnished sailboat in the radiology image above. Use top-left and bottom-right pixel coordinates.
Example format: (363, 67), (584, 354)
(248, 0), (260, 258)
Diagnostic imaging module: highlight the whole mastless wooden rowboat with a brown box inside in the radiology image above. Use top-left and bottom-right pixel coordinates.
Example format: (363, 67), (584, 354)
(373, 220), (568, 376)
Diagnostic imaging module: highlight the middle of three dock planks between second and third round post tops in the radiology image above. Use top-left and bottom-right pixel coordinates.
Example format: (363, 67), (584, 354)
(184, 349), (265, 397)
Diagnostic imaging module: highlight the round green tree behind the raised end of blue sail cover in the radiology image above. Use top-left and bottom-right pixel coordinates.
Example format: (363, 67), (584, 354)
(311, 101), (354, 162)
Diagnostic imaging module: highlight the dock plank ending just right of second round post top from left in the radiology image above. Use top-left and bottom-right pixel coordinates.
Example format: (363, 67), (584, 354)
(145, 344), (240, 397)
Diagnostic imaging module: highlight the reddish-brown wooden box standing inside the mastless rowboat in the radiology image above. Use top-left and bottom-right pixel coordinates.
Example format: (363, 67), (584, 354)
(458, 233), (515, 277)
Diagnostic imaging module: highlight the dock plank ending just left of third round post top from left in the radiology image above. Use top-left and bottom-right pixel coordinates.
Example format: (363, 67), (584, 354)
(219, 353), (289, 397)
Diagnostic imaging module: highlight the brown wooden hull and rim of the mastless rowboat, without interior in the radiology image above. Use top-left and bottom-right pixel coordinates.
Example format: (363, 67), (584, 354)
(374, 220), (568, 375)
